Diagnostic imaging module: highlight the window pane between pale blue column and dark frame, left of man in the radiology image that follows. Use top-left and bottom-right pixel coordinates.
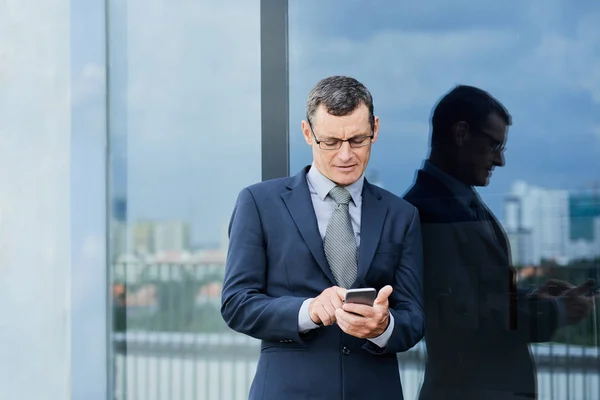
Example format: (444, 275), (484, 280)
(108, 0), (262, 399)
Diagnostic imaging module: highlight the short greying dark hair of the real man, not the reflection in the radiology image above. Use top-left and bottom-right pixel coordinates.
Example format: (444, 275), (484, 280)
(306, 76), (375, 129)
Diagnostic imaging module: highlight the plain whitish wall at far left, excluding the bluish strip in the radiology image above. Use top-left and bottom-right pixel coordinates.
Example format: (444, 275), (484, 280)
(0, 0), (71, 400)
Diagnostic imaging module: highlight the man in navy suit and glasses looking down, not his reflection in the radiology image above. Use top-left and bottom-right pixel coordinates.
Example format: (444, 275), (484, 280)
(221, 76), (424, 400)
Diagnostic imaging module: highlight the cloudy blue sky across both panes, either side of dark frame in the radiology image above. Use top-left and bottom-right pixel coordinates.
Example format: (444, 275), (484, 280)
(72, 0), (600, 242)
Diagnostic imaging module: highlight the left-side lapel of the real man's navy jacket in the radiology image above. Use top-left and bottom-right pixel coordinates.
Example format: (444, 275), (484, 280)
(281, 167), (335, 284)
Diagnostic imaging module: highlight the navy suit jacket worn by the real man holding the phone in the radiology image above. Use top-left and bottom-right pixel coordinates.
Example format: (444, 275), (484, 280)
(221, 167), (424, 400)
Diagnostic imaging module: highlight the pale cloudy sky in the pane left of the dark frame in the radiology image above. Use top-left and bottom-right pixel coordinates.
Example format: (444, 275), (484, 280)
(110, 0), (261, 241)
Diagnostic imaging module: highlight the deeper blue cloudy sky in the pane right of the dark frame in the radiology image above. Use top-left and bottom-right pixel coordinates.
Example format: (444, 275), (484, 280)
(290, 0), (600, 219)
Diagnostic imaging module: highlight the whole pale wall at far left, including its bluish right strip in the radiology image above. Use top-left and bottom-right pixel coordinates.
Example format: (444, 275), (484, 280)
(0, 1), (107, 399)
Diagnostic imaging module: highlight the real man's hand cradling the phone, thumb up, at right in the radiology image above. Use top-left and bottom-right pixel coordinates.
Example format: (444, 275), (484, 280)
(335, 285), (392, 339)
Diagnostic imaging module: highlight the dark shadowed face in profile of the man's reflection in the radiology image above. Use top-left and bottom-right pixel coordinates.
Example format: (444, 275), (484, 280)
(458, 113), (507, 186)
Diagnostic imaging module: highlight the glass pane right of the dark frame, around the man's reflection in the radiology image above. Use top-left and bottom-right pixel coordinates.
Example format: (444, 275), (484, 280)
(289, 0), (600, 399)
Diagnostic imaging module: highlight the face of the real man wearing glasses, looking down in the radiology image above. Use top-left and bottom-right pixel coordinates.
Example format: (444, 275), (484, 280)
(302, 104), (379, 186)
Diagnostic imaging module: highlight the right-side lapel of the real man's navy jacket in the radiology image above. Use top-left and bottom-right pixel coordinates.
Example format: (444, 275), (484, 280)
(356, 183), (388, 282)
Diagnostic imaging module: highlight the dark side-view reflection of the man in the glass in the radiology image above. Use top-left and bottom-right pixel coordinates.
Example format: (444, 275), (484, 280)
(404, 85), (593, 400)
